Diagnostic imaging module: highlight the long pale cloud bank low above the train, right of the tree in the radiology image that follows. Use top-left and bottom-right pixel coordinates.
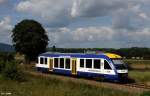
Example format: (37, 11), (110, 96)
(47, 27), (114, 47)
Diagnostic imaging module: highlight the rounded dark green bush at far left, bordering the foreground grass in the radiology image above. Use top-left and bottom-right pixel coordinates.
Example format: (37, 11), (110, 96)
(2, 61), (24, 81)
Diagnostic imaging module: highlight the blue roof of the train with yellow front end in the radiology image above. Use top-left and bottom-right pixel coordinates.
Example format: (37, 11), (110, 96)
(39, 52), (122, 59)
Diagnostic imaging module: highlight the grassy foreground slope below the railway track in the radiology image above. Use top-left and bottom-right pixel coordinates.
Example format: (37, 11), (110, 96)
(0, 75), (139, 96)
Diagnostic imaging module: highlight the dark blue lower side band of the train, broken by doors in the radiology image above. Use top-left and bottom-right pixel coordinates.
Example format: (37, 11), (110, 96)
(37, 67), (119, 80)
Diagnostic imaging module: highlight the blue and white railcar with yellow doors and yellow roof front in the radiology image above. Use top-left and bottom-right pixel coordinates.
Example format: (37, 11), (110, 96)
(36, 52), (128, 81)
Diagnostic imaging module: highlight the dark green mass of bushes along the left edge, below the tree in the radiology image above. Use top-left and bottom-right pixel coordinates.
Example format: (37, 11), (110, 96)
(0, 52), (25, 81)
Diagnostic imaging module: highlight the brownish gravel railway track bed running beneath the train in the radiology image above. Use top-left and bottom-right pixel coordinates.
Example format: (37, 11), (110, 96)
(25, 71), (150, 93)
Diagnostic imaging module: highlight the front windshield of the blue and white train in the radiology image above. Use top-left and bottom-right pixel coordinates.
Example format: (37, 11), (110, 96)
(112, 59), (127, 70)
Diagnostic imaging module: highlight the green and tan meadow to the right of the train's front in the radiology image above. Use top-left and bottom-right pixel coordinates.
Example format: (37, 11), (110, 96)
(124, 60), (150, 86)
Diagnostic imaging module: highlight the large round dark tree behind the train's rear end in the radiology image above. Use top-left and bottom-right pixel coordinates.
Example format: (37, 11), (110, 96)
(12, 20), (49, 63)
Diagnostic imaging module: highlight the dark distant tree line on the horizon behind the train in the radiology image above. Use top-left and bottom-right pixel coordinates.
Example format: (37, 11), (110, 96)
(48, 46), (150, 59)
